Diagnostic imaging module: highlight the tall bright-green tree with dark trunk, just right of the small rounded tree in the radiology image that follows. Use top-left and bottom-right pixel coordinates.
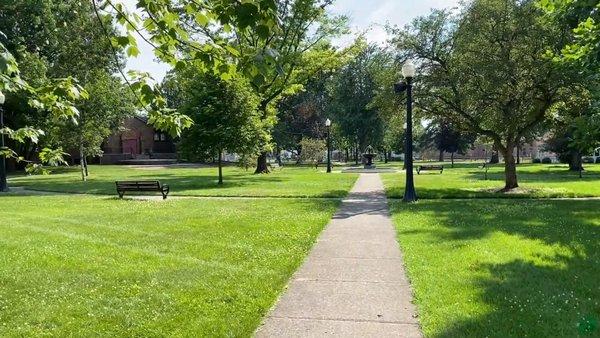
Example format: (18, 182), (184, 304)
(230, 0), (347, 173)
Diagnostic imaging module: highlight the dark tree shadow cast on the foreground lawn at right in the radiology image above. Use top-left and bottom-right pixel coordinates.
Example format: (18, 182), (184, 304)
(394, 201), (600, 337)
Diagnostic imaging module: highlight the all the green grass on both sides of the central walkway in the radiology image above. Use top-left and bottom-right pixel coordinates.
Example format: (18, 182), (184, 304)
(0, 163), (600, 337)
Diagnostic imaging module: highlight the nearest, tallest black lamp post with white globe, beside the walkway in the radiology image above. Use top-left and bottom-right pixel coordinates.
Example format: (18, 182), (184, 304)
(395, 60), (417, 203)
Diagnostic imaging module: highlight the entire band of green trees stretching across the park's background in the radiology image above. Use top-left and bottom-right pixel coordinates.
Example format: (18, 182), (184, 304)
(0, 0), (600, 190)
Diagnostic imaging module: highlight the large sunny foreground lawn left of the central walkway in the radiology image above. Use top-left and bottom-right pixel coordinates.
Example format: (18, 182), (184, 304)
(0, 194), (339, 337)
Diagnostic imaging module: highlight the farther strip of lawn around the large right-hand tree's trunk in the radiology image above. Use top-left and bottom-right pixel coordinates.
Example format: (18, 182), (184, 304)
(382, 163), (600, 199)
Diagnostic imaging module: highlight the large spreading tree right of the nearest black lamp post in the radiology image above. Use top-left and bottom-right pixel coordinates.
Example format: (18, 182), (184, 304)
(395, 0), (576, 191)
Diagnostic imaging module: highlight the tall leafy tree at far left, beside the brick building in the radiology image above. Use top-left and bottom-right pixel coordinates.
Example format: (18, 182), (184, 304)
(1, 0), (135, 179)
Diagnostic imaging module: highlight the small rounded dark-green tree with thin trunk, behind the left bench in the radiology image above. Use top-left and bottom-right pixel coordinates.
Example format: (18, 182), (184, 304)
(166, 71), (269, 184)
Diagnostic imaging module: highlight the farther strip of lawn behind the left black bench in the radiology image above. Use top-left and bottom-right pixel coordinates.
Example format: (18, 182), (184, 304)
(9, 166), (358, 197)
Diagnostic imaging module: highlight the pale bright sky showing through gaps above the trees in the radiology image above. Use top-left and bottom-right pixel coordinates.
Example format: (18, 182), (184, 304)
(126, 0), (459, 81)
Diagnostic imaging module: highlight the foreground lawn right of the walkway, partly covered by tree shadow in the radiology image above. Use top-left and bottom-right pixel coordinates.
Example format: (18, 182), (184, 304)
(391, 200), (600, 337)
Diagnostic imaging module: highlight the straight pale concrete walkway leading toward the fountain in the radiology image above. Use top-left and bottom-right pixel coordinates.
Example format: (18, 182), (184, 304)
(256, 174), (422, 337)
